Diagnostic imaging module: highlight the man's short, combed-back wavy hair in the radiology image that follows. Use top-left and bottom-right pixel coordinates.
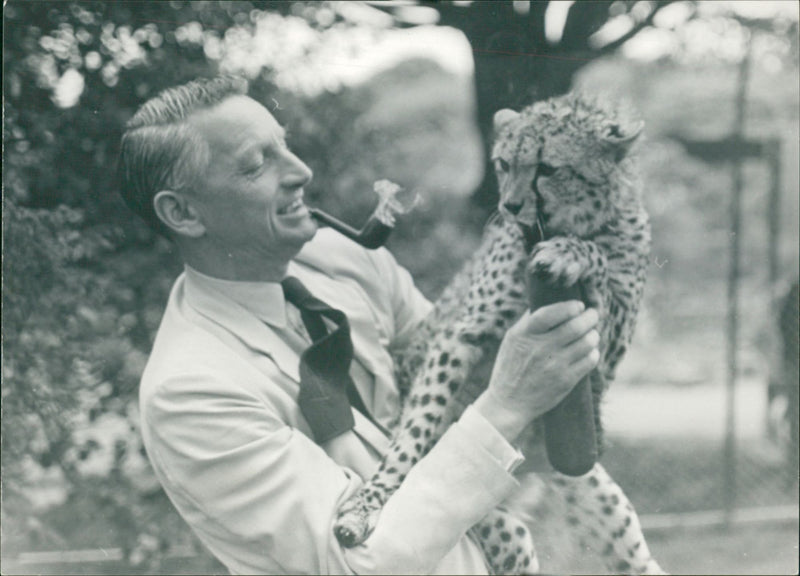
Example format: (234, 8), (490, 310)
(117, 76), (248, 235)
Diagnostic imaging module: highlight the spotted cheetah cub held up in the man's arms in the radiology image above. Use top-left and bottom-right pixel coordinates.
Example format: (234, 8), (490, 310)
(334, 94), (663, 574)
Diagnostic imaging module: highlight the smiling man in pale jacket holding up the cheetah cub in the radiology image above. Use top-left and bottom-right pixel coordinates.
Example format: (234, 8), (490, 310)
(115, 78), (599, 574)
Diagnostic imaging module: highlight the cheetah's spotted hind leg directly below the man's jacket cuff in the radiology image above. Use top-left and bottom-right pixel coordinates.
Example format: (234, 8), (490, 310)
(472, 508), (539, 574)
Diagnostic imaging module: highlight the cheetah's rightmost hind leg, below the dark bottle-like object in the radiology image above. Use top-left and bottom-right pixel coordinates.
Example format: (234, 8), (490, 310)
(552, 463), (666, 575)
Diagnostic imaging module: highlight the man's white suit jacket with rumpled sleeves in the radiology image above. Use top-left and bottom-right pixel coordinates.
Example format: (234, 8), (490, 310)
(140, 229), (518, 574)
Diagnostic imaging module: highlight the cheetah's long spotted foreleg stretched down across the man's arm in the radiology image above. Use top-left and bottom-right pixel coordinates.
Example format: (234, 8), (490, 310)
(334, 223), (527, 547)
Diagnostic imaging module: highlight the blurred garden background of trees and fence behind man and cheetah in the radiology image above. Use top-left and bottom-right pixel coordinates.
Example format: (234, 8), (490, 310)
(2, 0), (800, 574)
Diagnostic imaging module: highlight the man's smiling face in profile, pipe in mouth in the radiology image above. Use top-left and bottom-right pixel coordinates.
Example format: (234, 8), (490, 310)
(189, 96), (317, 263)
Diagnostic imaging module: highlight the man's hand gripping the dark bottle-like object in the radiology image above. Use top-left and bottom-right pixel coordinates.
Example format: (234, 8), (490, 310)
(474, 300), (600, 442)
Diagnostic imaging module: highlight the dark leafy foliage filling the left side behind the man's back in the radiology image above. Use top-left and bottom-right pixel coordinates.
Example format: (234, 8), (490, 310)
(2, 1), (396, 570)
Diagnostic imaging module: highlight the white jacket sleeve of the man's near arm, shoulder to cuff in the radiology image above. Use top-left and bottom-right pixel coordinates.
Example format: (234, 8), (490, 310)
(142, 371), (517, 574)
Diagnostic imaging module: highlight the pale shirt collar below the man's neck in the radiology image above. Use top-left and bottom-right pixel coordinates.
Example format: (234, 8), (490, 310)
(184, 264), (287, 328)
